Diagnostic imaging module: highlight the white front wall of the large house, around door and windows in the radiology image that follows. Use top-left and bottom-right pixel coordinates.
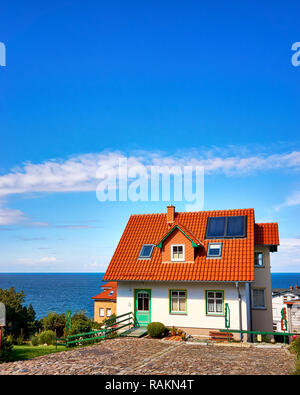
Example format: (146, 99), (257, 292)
(117, 281), (247, 330)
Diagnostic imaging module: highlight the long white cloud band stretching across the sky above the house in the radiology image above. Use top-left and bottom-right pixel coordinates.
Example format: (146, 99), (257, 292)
(0, 150), (300, 200)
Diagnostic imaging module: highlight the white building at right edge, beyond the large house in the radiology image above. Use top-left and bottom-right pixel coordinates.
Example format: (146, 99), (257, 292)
(272, 286), (300, 332)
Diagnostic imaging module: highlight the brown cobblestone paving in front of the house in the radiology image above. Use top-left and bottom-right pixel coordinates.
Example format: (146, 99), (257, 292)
(0, 338), (295, 375)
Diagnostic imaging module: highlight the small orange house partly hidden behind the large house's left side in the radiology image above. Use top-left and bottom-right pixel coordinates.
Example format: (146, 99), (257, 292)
(92, 281), (117, 323)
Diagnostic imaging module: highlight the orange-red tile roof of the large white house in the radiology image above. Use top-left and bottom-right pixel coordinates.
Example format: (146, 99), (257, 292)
(104, 208), (278, 281)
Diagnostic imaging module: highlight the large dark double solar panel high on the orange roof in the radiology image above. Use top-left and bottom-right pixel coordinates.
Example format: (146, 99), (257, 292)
(205, 215), (246, 239)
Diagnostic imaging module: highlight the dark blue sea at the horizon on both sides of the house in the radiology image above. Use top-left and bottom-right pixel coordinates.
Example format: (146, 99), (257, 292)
(0, 273), (300, 319)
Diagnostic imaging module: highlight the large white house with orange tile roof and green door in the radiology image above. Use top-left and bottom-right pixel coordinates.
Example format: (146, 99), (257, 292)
(104, 206), (279, 336)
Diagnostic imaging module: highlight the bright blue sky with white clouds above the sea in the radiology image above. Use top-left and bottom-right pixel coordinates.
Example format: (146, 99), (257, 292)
(0, 0), (300, 272)
